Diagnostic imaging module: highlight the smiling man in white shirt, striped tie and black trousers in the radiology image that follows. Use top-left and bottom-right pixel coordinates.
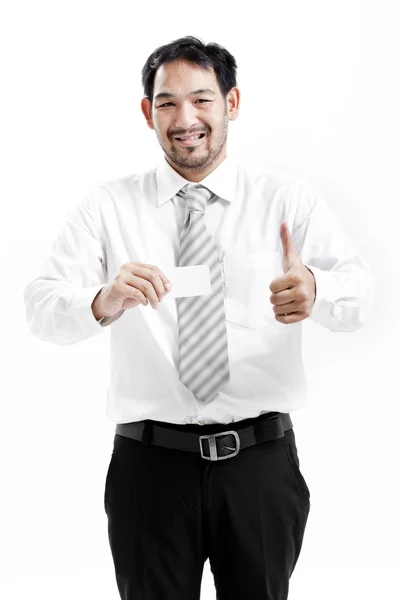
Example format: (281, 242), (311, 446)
(24, 37), (375, 600)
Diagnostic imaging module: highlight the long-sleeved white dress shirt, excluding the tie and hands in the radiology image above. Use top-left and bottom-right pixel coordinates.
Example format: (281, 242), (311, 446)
(24, 156), (376, 424)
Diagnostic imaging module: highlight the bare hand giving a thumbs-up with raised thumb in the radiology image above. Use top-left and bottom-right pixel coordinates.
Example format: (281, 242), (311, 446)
(269, 223), (316, 324)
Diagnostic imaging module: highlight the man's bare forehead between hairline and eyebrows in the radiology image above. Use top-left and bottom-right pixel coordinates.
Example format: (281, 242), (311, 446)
(154, 60), (218, 97)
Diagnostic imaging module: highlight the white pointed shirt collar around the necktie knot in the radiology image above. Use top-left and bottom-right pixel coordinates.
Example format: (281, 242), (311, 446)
(156, 151), (238, 207)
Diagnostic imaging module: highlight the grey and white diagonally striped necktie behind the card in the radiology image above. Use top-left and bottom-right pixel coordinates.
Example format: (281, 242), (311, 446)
(175, 184), (230, 402)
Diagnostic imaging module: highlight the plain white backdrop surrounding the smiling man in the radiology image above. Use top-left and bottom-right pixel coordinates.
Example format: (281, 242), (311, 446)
(0, 0), (400, 600)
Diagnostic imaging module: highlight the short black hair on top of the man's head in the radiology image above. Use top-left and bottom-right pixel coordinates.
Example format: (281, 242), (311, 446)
(142, 35), (237, 104)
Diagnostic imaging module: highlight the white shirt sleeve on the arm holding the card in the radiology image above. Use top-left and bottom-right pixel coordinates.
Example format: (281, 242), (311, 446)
(23, 192), (124, 345)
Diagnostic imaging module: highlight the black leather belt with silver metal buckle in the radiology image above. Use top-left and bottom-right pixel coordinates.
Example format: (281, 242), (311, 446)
(115, 412), (293, 460)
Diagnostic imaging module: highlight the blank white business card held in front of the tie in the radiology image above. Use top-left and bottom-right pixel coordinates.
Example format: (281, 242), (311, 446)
(163, 265), (211, 298)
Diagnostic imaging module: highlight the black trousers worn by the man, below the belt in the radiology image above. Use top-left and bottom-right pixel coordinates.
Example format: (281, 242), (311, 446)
(104, 417), (310, 600)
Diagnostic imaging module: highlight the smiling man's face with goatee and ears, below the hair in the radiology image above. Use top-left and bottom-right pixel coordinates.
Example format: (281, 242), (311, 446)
(142, 60), (239, 181)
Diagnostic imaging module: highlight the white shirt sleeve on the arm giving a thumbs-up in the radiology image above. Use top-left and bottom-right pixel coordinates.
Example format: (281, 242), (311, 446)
(292, 181), (376, 331)
